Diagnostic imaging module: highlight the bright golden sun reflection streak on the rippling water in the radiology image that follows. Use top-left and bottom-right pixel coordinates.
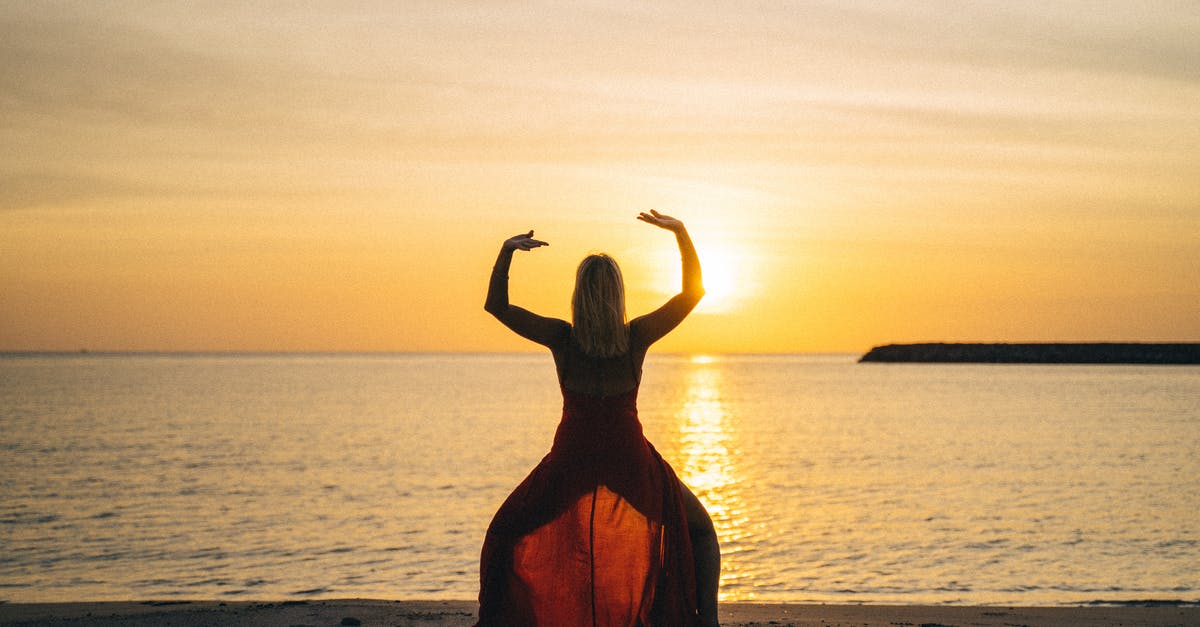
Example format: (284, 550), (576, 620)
(677, 356), (754, 601)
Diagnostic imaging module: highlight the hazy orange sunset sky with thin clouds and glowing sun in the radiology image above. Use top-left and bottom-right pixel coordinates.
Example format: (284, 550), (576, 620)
(0, 1), (1200, 352)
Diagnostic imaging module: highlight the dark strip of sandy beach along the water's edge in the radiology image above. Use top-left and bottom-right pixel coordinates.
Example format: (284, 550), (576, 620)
(0, 599), (1200, 627)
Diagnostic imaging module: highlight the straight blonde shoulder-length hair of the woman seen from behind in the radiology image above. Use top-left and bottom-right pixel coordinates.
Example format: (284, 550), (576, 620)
(571, 253), (629, 357)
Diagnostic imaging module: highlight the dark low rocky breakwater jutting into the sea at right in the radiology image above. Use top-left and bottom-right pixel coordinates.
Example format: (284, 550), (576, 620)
(859, 342), (1200, 365)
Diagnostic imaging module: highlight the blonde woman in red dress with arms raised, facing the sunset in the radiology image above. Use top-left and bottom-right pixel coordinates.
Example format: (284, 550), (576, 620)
(479, 210), (720, 627)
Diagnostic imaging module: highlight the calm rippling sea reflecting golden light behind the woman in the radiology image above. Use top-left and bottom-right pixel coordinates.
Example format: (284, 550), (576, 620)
(0, 354), (1200, 604)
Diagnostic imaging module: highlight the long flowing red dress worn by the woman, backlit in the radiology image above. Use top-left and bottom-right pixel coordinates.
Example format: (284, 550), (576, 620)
(478, 381), (697, 627)
